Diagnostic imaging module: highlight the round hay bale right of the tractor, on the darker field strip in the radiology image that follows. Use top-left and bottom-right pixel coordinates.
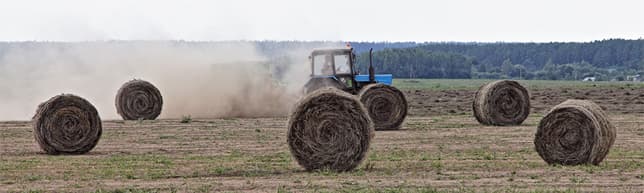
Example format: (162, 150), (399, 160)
(472, 80), (530, 126)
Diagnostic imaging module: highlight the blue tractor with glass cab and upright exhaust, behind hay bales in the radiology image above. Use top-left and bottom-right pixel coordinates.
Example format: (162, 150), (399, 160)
(304, 48), (392, 94)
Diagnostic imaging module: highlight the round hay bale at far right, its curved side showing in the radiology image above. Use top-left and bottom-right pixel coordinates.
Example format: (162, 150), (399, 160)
(534, 100), (616, 165)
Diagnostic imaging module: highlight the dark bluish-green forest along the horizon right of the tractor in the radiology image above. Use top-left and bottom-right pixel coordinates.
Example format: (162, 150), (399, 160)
(358, 39), (644, 80)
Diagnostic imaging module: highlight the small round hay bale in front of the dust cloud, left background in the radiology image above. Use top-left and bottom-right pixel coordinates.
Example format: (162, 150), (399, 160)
(116, 79), (163, 120)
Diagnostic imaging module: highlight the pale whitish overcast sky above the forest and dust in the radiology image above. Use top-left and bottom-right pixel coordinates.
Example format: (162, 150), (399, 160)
(0, 0), (644, 42)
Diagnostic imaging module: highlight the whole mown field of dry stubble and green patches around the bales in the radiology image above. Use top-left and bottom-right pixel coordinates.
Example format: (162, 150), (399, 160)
(0, 88), (644, 192)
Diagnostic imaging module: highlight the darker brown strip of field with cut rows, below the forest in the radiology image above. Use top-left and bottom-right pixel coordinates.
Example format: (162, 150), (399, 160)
(404, 81), (644, 116)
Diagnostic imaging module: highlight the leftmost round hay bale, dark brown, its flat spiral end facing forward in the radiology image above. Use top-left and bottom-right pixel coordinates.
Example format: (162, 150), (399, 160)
(33, 94), (102, 155)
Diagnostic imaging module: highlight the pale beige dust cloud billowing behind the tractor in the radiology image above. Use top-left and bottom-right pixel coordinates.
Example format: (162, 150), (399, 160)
(0, 41), (332, 120)
